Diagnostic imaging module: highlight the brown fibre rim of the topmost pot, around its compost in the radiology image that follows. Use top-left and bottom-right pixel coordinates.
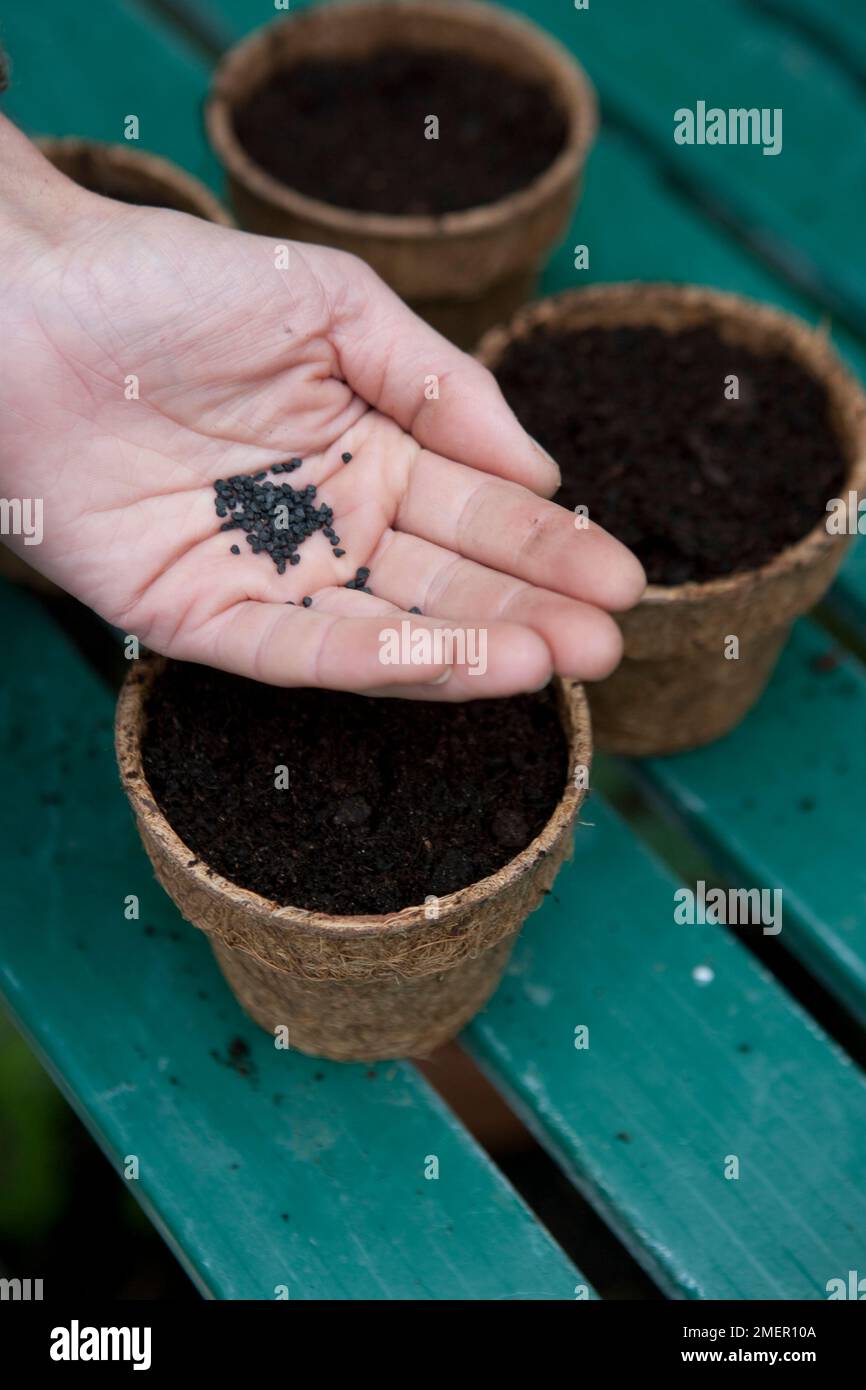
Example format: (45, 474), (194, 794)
(204, 0), (598, 242)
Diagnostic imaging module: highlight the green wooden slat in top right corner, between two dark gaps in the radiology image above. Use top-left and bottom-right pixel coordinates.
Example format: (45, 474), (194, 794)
(547, 0), (866, 331)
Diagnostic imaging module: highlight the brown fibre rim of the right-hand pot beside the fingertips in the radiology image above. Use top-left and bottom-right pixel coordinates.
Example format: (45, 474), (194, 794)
(475, 281), (866, 613)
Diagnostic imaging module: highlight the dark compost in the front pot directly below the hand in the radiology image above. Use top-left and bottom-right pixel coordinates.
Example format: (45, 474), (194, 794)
(142, 662), (569, 913)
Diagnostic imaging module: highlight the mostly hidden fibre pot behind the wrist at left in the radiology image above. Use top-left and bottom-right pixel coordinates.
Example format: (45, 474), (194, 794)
(0, 136), (234, 595)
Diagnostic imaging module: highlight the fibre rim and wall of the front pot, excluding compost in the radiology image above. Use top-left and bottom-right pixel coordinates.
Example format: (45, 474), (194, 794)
(115, 657), (591, 1061)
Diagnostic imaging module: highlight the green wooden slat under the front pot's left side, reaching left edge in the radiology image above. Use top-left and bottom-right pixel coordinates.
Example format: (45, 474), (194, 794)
(0, 584), (587, 1300)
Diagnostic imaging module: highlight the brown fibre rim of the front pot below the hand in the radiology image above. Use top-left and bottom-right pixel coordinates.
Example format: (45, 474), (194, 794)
(114, 653), (592, 940)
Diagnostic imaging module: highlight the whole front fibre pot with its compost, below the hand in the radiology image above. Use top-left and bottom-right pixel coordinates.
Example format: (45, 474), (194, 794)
(115, 657), (591, 1061)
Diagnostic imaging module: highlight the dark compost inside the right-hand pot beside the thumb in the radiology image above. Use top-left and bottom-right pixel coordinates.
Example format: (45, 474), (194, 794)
(495, 327), (845, 585)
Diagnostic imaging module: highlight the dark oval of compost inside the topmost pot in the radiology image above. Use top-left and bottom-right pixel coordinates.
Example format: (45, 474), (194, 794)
(234, 46), (567, 214)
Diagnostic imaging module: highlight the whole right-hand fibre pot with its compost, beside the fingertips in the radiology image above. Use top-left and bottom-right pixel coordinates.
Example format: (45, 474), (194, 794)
(478, 284), (866, 756)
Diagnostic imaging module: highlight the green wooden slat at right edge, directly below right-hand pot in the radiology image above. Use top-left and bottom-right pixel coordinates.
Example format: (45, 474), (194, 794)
(641, 623), (866, 1022)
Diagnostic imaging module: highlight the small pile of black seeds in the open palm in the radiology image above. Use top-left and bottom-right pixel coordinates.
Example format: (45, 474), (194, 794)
(214, 459), (340, 574)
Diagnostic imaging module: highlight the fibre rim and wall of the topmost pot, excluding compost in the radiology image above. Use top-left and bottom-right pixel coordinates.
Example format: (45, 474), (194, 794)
(207, 0), (596, 346)
